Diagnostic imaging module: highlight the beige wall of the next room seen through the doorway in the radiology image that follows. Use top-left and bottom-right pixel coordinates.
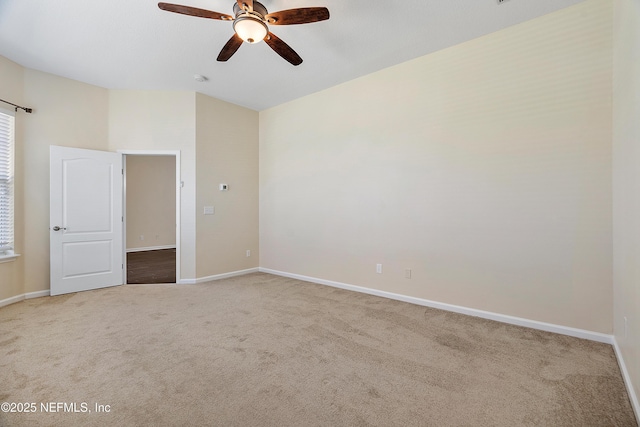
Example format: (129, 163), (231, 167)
(126, 155), (176, 250)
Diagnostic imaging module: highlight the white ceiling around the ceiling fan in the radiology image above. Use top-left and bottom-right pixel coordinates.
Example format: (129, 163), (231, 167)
(0, 0), (583, 111)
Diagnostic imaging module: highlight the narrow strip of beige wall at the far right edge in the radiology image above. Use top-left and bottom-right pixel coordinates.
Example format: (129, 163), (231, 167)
(613, 0), (640, 408)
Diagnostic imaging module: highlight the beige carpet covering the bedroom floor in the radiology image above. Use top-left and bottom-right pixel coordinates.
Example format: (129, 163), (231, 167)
(0, 273), (636, 426)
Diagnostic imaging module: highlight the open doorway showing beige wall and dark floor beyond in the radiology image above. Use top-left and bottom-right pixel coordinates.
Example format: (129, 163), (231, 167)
(123, 151), (180, 284)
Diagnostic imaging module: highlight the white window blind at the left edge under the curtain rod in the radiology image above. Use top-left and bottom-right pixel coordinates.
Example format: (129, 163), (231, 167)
(0, 111), (15, 255)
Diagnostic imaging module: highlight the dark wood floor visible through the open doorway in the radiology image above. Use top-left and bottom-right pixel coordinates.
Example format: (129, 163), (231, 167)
(127, 249), (176, 284)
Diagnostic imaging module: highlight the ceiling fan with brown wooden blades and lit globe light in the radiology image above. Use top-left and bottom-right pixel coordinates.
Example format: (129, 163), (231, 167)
(158, 0), (329, 65)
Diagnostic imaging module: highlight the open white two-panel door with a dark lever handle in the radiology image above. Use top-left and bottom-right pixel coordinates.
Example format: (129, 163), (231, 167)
(49, 146), (124, 295)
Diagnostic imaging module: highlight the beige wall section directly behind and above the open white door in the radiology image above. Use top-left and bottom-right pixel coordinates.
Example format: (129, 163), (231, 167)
(22, 69), (108, 292)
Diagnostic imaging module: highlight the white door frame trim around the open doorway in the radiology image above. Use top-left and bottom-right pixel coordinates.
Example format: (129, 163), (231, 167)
(118, 150), (182, 285)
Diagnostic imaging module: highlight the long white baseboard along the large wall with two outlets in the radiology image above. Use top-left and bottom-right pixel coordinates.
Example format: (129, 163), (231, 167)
(260, 268), (613, 344)
